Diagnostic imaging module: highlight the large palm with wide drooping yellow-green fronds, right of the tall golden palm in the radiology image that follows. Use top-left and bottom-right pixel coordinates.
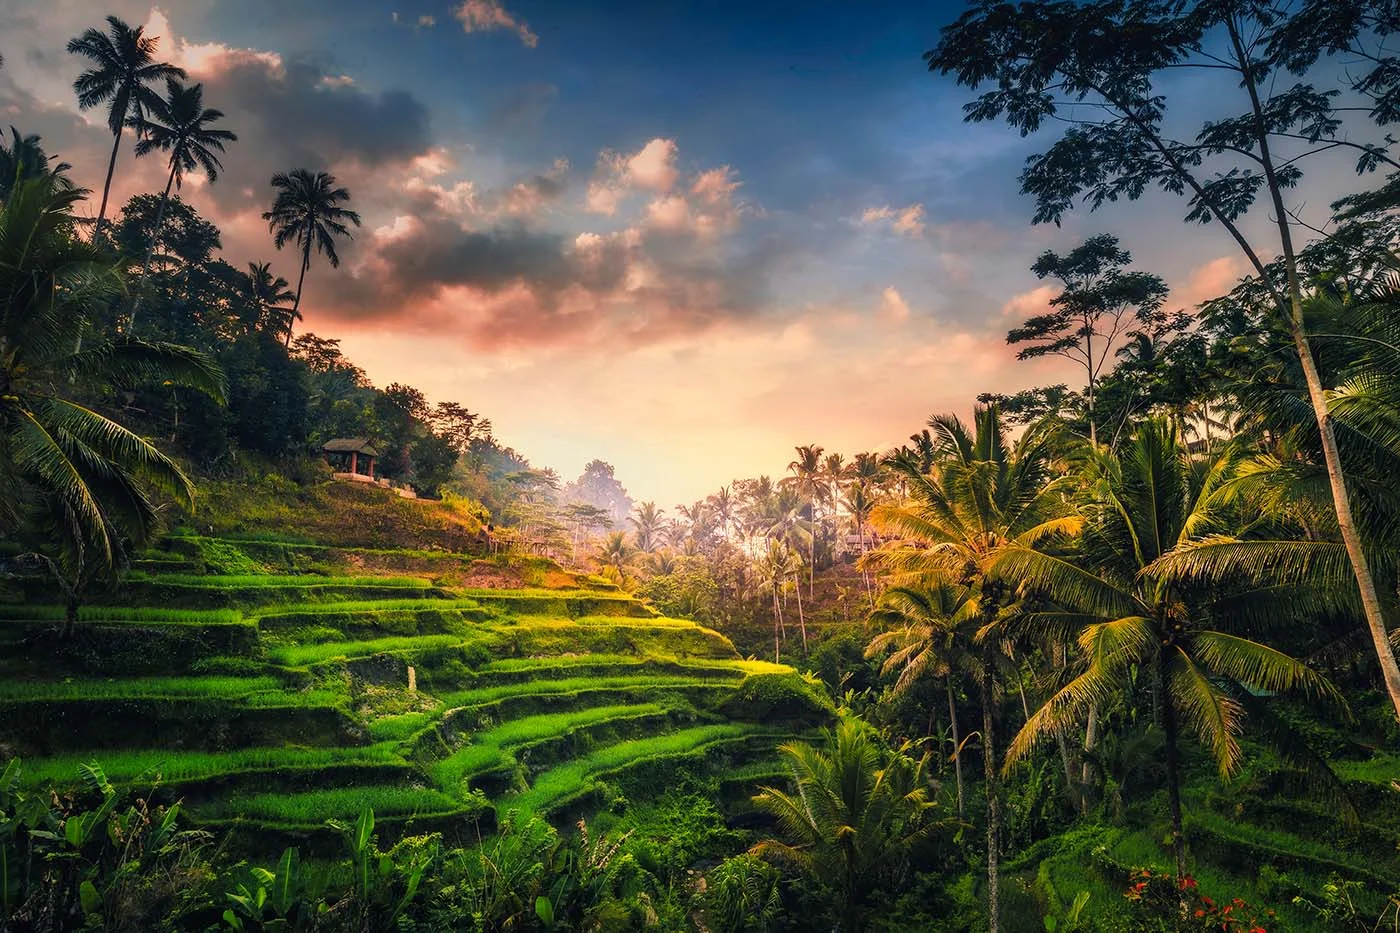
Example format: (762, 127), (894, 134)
(993, 419), (1344, 878)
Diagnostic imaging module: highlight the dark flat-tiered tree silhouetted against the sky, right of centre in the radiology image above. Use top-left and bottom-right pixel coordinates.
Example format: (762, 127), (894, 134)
(1007, 234), (1168, 444)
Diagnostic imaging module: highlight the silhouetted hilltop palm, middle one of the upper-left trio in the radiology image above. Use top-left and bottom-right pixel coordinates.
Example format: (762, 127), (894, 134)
(127, 78), (238, 328)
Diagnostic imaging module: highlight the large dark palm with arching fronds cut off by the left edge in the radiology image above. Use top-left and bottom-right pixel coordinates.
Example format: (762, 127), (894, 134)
(0, 175), (223, 628)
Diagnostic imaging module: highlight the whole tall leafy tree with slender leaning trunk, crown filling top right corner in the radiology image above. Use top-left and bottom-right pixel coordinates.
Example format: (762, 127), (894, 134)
(925, 0), (1400, 717)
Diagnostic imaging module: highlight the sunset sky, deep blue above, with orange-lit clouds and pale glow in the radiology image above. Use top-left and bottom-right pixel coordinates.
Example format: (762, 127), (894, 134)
(0, 0), (1271, 507)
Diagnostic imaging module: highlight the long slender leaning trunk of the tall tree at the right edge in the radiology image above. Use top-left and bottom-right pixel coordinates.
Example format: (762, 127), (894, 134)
(1228, 20), (1400, 720)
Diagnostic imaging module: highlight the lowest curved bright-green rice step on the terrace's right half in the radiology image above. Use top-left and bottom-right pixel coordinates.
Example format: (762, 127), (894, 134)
(498, 723), (787, 813)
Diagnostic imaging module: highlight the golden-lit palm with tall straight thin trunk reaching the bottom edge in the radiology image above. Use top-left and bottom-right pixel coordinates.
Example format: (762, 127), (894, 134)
(871, 406), (1078, 933)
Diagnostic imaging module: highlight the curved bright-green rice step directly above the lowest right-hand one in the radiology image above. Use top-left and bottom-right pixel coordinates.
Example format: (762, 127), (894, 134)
(427, 703), (671, 794)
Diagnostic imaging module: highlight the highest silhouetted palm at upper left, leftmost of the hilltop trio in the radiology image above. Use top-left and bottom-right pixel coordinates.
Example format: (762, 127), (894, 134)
(69, 17), (185, 230)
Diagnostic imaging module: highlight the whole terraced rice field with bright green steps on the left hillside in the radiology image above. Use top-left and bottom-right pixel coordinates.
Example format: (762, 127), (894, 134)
(0, 539), (829, 834)
